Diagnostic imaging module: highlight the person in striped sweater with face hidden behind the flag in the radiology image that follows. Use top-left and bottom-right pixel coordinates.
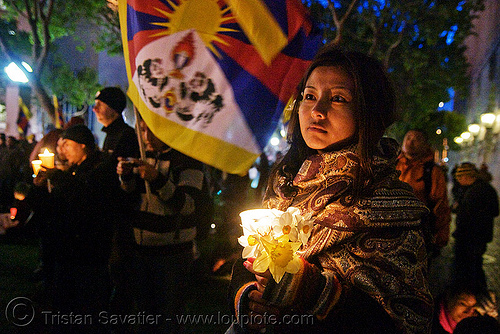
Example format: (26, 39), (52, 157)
(116, 120), (208, 333)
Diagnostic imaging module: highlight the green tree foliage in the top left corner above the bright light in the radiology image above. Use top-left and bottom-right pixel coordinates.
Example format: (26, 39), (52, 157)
(0, 0), (117, 119)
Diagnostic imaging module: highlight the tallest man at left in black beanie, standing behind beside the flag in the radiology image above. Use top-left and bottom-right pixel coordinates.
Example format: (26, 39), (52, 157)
(92, 87), (140, 333)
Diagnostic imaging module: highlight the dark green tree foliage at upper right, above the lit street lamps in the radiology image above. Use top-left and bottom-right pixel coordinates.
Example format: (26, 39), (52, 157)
(306, 0), (484, 149)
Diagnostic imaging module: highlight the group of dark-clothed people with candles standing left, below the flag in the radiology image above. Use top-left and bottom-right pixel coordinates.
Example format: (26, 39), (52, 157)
(1, 87), (212, 333)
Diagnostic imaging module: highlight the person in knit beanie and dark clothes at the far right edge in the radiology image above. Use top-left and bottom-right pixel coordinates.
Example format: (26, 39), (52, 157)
(453, 162), (499, 288)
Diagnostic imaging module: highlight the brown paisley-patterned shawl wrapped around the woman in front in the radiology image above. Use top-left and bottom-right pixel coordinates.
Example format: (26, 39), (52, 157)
(265, 140), (432, 333)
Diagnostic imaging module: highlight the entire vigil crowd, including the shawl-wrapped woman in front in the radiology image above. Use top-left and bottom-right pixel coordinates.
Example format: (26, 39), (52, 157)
(0, 46), (500, 334)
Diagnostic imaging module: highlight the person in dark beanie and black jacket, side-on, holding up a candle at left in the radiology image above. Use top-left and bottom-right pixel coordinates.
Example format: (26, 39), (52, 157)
(26, 125), (121, 333)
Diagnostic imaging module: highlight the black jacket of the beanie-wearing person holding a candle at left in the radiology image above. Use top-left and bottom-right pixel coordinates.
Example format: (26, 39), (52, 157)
(27, 152), (120, 265)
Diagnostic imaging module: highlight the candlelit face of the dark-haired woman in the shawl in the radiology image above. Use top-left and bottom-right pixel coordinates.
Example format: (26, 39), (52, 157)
(299, 66), (356, 153)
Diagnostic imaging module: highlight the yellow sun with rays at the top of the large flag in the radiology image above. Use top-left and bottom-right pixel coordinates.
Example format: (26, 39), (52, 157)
(151, 0), (237, 57)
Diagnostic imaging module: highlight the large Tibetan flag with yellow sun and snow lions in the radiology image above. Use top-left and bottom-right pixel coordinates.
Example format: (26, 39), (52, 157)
(119, 0), (321, 175)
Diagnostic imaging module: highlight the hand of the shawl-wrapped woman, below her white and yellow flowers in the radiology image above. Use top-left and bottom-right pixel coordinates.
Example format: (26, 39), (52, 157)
(243, 258), (279, 330)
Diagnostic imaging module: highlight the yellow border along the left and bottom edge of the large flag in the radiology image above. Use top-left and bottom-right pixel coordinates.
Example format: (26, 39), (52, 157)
(118, 0), (260, 176)
